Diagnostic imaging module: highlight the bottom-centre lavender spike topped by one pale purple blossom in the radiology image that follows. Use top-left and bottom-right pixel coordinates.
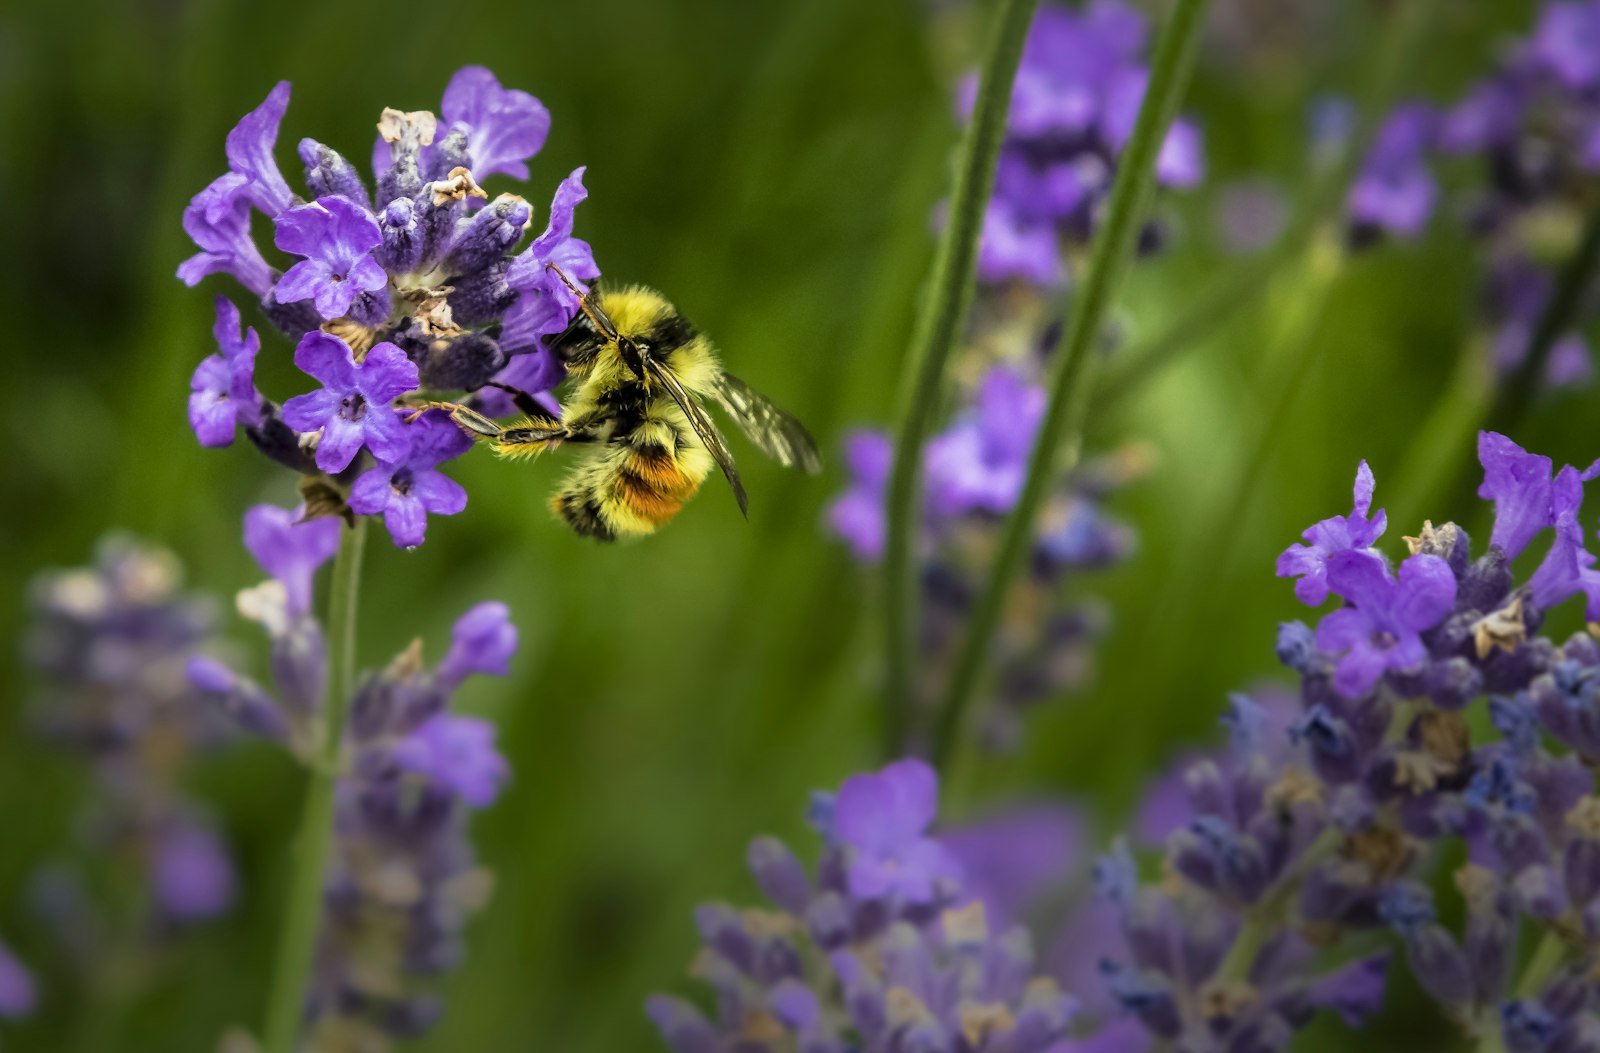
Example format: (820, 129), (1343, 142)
(646, 760), (1075, 1053)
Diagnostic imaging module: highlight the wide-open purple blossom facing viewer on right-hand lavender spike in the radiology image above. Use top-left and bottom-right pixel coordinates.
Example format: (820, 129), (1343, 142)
(1317, 551), (1456, 698)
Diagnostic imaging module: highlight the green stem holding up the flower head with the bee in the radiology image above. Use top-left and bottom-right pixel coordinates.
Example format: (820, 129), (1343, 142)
(262, 518), (366, 1053)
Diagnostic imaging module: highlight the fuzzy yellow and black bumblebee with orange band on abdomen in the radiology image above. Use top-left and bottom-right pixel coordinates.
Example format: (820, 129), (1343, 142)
(427, 264), (822, 541)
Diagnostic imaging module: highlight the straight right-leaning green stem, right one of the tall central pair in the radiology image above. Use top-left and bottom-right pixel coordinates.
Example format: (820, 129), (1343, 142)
(933, 0), (1211, 768)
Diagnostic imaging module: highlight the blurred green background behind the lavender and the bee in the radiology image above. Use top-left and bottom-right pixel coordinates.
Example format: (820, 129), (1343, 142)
(0, 0), (1600, 1053)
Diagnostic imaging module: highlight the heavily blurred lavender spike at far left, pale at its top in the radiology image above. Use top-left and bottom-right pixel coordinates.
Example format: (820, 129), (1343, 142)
(24, 538), (234, 921)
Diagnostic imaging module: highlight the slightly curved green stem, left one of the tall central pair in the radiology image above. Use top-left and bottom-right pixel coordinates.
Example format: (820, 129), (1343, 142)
(883, 0), (1038, 755)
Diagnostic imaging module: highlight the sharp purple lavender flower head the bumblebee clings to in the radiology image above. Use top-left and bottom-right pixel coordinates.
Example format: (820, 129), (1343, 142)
(178, 67), (598, 547)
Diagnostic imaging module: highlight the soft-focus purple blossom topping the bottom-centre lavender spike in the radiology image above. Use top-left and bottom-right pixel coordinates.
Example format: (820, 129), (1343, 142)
(834, 760), (958, 903)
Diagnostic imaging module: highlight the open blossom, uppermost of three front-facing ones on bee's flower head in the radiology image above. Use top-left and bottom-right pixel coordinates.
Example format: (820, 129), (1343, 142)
(272, 197), (389, 320)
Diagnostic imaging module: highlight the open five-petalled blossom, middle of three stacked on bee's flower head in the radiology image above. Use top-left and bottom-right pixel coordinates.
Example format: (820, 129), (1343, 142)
(283, 330), (418, 472)
